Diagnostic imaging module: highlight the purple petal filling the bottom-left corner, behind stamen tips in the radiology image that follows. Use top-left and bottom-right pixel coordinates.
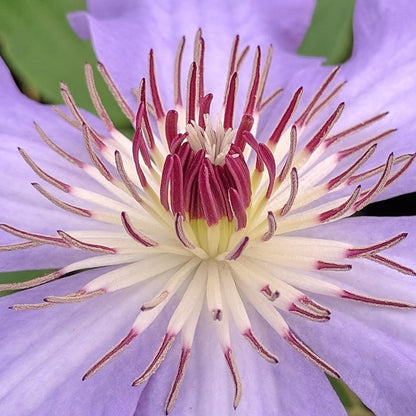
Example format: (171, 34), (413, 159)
(0, 271), (163, 415)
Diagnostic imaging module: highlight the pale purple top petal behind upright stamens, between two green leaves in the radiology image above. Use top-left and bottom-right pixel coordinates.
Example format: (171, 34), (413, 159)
(69, 0), (315, 110)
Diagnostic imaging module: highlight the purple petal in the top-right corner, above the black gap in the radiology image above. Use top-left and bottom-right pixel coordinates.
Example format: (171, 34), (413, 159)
(334, 1), (416, 200)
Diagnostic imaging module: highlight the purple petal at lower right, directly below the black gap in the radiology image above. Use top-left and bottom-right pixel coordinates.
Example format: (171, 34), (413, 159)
(288, 217), (416, 415)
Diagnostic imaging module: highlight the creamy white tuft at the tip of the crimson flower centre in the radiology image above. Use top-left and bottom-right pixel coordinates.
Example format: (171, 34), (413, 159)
(186, 114), (237, 166)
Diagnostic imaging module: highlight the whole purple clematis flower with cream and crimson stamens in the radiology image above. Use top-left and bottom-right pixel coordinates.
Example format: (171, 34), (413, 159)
(0, 0), (416, 415)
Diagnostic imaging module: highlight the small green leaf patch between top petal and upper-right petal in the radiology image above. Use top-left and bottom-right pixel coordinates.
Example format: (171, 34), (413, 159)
(298, 0), (355, 65)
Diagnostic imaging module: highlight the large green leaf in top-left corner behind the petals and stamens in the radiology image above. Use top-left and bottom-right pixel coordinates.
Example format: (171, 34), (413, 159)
(0, 0), (128, 126)
